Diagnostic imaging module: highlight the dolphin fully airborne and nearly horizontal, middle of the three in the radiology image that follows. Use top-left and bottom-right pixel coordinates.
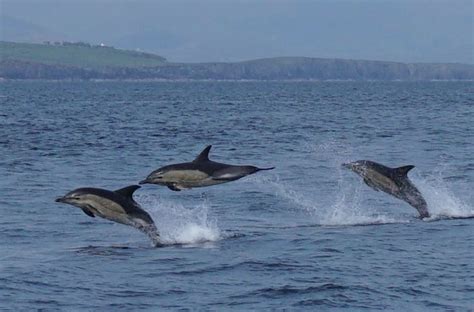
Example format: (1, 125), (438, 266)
(140, 145), (275, 191)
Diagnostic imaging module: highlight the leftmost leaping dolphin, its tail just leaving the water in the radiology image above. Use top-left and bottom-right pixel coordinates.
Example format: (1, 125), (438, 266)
(56, 185), (160, 246)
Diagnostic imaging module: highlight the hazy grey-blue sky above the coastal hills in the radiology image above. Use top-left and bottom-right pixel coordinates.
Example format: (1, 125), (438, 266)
(0, 0), (474, 63)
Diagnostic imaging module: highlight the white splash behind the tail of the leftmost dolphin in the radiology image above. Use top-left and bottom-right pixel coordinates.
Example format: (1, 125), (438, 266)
(137, 195), (221, 245)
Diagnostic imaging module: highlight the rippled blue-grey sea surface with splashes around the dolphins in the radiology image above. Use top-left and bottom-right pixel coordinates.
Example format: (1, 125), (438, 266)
(0, 82), (474, 311)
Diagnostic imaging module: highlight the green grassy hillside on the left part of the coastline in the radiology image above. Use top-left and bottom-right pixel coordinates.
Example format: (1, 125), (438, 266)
(0, 41), (166, 69)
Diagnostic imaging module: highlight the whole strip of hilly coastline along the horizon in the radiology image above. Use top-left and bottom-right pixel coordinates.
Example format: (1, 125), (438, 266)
(0, 42), (474, 80)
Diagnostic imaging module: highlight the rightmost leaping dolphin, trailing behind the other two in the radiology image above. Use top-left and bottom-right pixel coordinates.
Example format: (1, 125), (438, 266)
(343, 160), (430, 218)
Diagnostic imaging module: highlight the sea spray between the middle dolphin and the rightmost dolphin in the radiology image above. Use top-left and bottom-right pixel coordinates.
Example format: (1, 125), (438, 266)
(250, 141), (412, 225)
